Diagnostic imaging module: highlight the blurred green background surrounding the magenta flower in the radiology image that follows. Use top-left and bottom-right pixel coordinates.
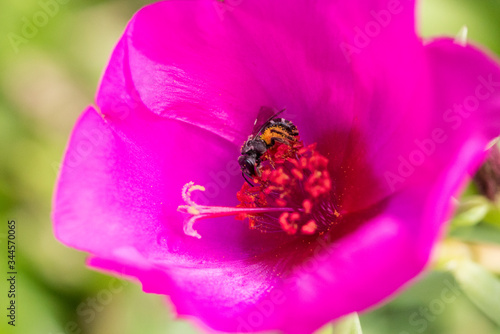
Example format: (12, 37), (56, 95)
(0, 0), (500, 334)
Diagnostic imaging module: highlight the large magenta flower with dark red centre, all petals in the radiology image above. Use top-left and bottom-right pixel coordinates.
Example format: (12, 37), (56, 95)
(53, 0), (500, 333)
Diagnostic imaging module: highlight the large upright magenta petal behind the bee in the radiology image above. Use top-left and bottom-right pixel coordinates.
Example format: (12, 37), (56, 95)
(93, 0), (425, 214)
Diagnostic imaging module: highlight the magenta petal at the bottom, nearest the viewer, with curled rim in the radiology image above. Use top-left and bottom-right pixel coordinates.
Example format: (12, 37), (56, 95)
(81, 189), (458, 334)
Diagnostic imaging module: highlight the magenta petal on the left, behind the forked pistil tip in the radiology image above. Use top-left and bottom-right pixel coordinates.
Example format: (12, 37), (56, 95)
(53, 108), (292, 262)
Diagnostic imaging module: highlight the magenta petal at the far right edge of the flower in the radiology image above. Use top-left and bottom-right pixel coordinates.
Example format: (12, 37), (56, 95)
(377, 39), (500, 196)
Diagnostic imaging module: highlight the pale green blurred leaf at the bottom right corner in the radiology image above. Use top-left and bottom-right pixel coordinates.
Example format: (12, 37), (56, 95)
(450, 260), (500, 325)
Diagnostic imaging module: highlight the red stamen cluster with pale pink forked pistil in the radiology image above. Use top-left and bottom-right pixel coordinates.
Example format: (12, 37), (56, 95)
(177, 139), (340, 238)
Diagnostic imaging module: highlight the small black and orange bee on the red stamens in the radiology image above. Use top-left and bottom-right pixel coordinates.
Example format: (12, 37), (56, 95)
(238, 107), (299, 186)
